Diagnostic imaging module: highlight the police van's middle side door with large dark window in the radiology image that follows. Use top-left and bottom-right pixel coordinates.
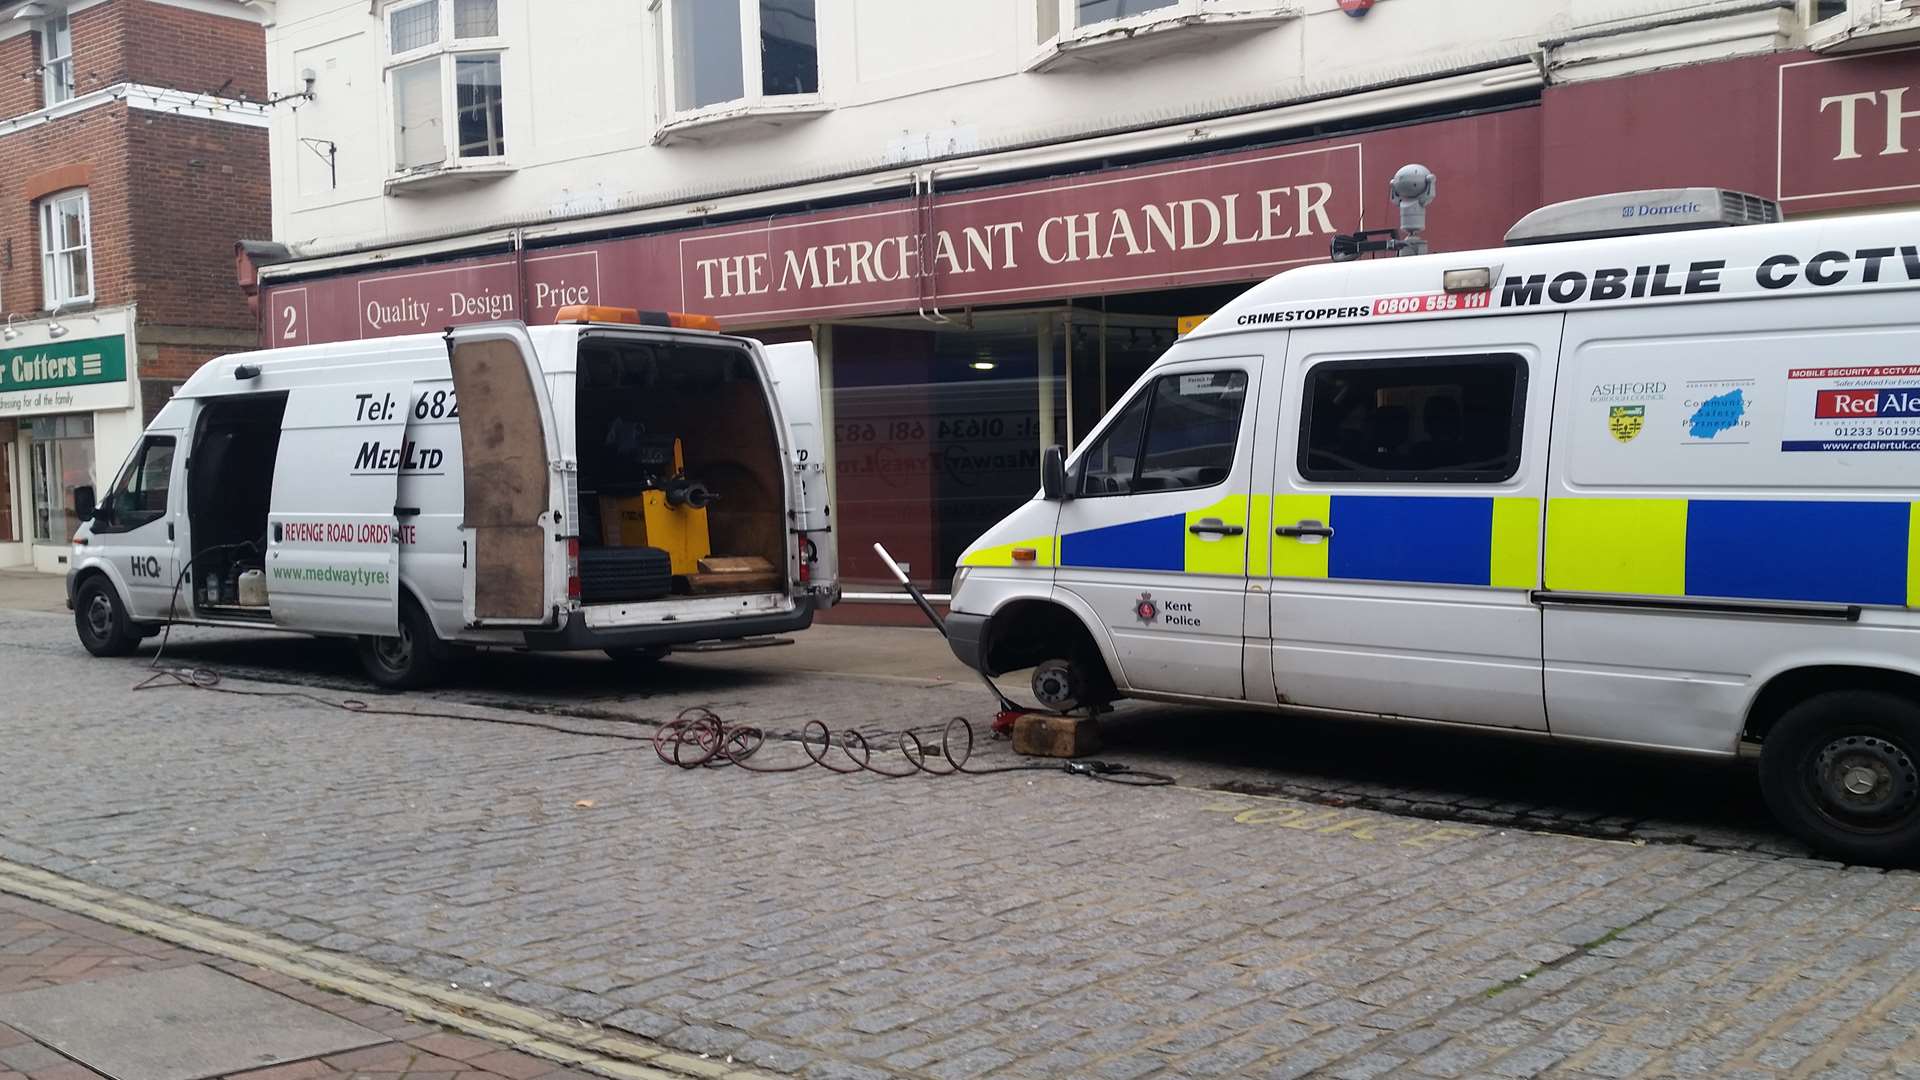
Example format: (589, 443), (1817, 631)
(1263, 315), (1563, 730)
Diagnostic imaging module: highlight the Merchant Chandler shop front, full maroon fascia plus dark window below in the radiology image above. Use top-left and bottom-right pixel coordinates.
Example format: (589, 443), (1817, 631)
(247, 48), (1920, 598)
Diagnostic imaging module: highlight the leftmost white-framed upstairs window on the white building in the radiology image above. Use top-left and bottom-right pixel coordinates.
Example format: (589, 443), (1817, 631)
(386, 0), (507, 173)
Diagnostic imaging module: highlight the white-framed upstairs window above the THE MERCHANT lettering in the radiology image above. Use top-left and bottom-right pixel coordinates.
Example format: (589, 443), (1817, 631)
(662, 0), (820, 113)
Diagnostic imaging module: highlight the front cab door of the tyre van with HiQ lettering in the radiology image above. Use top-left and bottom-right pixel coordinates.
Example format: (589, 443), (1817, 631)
(92, 430), (186, 621)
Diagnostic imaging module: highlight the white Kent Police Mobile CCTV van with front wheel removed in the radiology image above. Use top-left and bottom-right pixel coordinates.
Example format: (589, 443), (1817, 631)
(948, 190), (1920, 861)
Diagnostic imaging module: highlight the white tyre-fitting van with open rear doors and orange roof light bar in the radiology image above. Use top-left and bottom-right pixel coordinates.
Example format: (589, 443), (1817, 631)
(67, 307), (839, 688)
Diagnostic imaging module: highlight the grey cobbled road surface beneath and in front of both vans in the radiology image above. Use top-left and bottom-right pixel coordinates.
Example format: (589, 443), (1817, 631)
(0, 613), (1920, 1080)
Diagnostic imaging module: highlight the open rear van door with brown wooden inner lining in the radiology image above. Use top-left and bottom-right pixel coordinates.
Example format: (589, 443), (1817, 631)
(447, 323), (566, 626)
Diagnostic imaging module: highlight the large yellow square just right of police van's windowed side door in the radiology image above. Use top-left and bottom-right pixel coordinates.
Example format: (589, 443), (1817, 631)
(1548, 500), (1686, 596)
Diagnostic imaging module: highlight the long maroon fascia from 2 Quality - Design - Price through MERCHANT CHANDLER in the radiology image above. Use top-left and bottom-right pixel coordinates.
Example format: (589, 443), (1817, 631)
(263, 110), (1540, 346)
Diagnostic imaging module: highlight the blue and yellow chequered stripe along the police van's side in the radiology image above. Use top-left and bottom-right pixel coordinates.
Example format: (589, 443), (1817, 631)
(964, 494), (1920, 607)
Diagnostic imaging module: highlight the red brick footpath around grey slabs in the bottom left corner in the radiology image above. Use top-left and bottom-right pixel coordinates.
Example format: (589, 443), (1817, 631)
(0, 896), (589, 1080)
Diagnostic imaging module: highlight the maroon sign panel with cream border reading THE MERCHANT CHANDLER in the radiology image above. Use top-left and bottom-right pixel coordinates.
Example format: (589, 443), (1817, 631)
(676, 142), (1365, 321)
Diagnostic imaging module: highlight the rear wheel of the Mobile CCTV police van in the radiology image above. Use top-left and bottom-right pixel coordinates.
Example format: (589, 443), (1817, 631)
(1761, 690), (1920, 865)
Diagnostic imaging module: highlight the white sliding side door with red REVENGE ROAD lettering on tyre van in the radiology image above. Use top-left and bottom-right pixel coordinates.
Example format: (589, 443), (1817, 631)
(267, 382), (413, 638)
